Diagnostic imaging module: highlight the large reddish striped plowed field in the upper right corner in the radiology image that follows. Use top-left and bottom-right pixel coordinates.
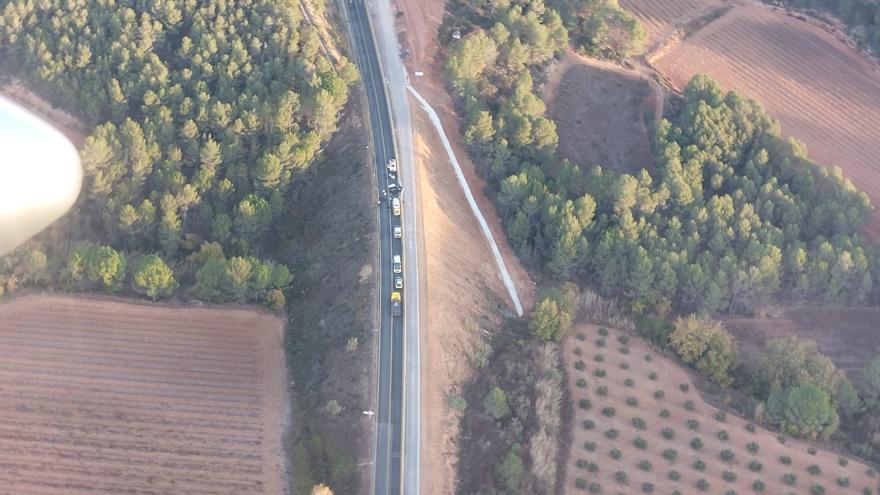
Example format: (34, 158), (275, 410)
(654, 6), (880, 233)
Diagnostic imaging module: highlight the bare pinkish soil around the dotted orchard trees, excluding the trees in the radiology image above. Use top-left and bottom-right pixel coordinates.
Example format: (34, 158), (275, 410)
(563, 325), (878, 495)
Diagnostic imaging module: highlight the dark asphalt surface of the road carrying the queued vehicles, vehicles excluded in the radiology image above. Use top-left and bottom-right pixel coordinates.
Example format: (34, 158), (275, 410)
(346, 0), (406, 495)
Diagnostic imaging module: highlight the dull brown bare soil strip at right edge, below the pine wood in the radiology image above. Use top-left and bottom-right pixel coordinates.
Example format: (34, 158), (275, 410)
(724, 307), (880, 379)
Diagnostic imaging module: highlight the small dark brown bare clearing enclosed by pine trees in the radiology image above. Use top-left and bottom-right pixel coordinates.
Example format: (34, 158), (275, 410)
(543, 51), (659, 173)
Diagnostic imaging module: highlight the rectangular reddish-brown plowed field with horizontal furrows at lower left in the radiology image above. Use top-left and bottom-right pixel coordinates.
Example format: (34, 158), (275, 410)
(0, 297), (284, 495)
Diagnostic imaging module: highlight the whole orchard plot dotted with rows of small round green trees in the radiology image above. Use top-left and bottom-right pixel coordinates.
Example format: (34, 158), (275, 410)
(564, 325), (880, 495)
